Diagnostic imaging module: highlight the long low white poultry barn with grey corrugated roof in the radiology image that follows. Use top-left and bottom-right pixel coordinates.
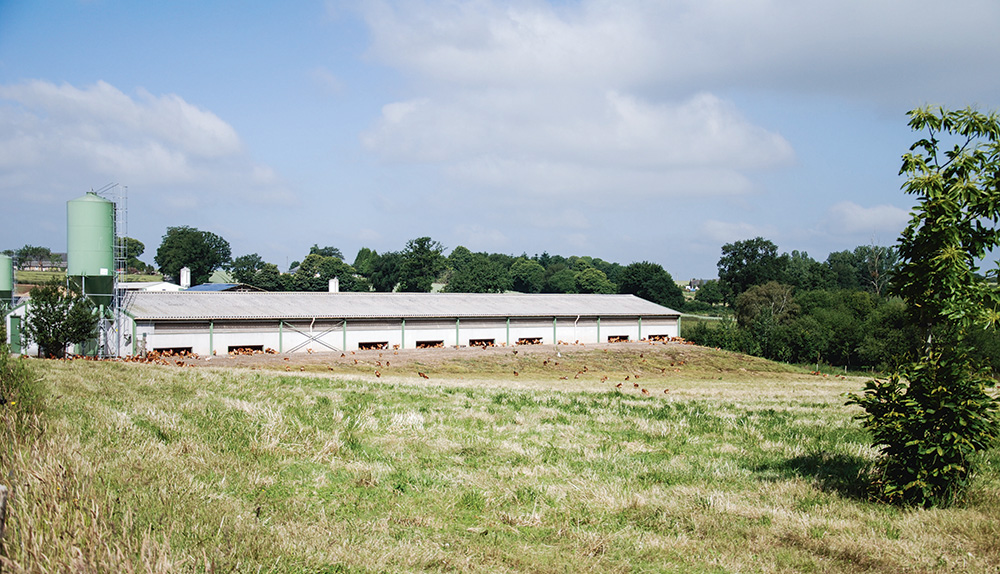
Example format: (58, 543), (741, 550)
(122, 291), (680, 355)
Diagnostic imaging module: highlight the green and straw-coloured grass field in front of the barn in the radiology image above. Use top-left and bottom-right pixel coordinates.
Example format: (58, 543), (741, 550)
(0, 344), (1000, 573)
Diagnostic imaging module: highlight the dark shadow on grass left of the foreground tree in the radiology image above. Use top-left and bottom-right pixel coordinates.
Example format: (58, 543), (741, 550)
(754, 451), (872, 500)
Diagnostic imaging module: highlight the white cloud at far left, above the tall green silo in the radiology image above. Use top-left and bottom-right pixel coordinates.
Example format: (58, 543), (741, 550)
(0, 80), (290, 209)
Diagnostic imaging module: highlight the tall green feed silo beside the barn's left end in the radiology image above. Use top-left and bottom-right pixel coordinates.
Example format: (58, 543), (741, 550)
(66, 192), (115, 309)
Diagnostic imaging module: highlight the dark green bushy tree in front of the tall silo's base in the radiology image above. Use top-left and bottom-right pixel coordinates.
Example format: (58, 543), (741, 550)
(24, 280), (98, 358)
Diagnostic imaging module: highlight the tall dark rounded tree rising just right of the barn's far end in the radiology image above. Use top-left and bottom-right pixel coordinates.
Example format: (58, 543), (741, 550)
(718, 237), (789, 304)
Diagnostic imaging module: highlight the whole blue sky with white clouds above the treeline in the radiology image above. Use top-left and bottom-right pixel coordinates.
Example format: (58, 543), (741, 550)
(0, 0), (1000, 280)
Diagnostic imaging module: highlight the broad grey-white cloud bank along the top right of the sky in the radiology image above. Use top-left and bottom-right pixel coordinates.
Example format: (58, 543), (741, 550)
(363, 0), (1000, 99)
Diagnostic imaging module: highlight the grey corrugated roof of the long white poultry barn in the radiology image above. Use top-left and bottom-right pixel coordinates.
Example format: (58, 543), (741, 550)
(125, 291), (679, 320)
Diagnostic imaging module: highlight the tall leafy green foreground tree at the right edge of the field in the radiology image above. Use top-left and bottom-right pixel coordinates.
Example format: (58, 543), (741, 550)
(849, 108), (1000, 506)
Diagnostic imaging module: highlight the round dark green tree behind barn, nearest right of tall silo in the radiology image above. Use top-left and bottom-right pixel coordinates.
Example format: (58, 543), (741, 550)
(153, 225), (232, 285)
